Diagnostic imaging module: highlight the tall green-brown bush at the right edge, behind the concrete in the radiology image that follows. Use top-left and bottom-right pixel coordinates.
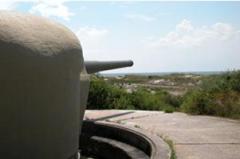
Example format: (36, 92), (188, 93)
(181, 71), (240, 118)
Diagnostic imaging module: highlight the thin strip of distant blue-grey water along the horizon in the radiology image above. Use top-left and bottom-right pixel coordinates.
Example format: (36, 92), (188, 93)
(99, 71), (224, 77)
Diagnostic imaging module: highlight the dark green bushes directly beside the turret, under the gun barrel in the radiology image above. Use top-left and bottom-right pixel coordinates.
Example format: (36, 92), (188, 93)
(87, 77), (179, 111)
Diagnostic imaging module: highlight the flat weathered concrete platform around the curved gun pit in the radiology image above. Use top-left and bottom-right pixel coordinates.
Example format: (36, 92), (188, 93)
(85, 110), (240, 159)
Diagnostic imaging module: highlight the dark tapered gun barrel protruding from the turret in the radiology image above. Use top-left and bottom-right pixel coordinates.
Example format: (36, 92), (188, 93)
(85, 60), (133, 74)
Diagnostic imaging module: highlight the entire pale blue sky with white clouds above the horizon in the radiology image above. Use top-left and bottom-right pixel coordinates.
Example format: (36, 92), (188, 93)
(0, 0), (240, 73)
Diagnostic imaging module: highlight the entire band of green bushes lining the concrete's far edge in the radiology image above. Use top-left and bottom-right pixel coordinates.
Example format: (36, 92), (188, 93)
(87, 71), (240, 118)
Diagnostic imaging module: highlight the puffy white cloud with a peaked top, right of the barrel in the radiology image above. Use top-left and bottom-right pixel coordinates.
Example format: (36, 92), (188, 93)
(147, 19), (239, 48)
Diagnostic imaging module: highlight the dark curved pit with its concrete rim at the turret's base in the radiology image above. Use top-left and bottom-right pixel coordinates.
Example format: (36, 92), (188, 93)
(80, 121), (170, 159)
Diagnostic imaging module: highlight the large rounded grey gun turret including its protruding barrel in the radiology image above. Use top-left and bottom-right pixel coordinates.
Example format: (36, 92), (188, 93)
(0, 11), (133, 159)
